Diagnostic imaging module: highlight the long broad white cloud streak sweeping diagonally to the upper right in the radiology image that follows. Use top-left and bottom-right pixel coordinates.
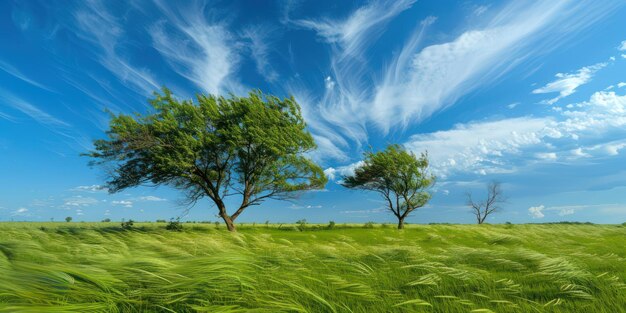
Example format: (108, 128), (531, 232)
(370, 1), (607, 130)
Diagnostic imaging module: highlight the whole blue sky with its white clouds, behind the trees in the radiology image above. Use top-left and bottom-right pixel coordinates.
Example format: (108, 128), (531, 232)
(0, 0), (626, 223)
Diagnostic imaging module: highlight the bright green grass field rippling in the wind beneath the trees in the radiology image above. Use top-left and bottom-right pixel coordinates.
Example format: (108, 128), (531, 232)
(0, 223), (626, 313)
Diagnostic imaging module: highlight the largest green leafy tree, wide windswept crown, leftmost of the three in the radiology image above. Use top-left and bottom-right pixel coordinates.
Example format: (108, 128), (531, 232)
(87, 88), (327, 231)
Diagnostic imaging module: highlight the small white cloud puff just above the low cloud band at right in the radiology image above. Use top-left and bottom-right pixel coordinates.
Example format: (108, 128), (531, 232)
(533, 63), (607, 104)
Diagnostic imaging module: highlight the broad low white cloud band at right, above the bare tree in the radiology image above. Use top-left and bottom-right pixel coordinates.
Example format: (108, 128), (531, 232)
(404, 91), (626, 178)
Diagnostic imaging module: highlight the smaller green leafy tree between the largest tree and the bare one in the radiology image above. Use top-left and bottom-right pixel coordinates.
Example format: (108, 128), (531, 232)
(342, 145), (435, 229)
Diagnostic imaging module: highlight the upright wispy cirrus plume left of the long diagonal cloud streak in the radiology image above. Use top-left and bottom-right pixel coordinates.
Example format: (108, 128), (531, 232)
(287, 0), (415, 161)
